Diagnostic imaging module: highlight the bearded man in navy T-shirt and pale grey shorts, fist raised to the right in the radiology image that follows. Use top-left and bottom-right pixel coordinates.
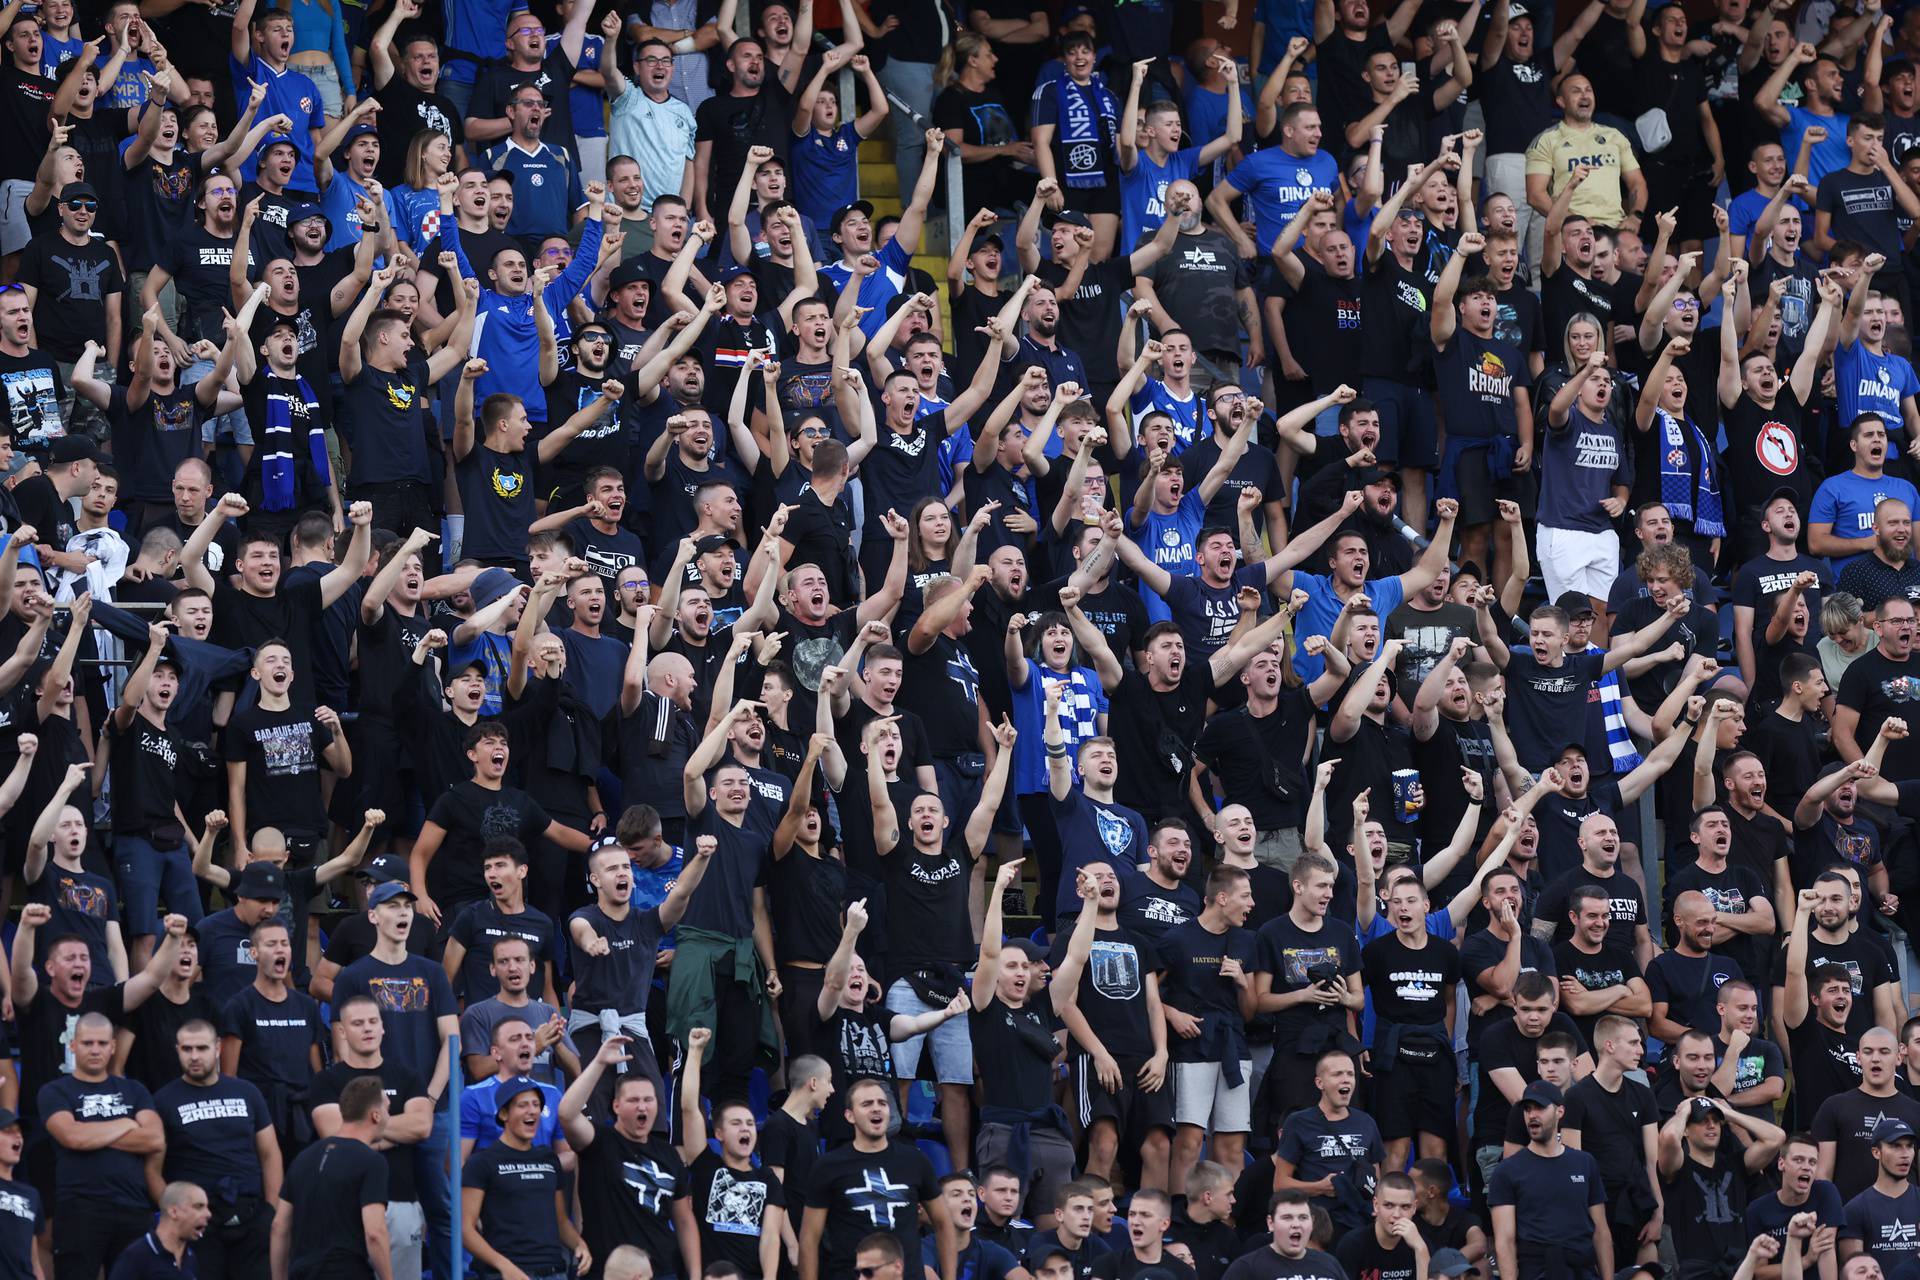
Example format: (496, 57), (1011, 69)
(566, 839), (716, 1113)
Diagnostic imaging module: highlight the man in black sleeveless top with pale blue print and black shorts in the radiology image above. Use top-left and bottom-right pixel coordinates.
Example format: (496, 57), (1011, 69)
(1048, 862), (1173, 1197)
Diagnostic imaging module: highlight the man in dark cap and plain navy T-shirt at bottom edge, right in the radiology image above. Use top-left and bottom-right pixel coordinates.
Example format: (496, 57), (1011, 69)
(1486, 1080), (1613, 1280)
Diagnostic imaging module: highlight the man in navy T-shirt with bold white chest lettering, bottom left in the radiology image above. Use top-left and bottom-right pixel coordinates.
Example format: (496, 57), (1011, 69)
(146, 1019), (280, 1280)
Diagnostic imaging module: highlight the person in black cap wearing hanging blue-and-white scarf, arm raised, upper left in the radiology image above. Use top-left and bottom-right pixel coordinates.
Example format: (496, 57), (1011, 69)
(234, 284), (346, 543)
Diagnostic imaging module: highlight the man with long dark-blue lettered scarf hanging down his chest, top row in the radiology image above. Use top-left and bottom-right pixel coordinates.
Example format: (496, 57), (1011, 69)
(1033, 31), (1119, 263)
